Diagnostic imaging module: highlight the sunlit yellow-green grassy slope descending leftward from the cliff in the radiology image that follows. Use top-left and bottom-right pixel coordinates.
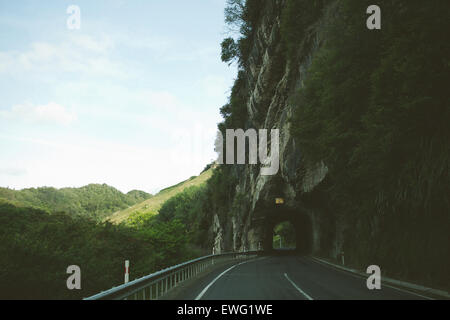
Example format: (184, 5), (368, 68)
(107, 168), (213, 223)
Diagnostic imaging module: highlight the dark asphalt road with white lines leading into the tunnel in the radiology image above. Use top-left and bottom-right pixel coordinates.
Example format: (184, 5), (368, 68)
(176, 255), (425, 300)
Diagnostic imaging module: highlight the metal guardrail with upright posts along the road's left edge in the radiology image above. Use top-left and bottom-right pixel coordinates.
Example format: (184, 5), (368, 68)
(84, 251), (262, 300)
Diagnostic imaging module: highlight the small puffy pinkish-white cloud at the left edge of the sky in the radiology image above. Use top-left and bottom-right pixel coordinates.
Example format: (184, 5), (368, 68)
(0, 102), (77, 126)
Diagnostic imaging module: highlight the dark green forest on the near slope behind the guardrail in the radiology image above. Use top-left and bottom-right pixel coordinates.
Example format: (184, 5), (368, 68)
(0, 200), (199, 299)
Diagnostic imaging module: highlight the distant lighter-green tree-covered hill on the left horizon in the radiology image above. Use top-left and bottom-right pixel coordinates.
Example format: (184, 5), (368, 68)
(0, 184), (152, 219)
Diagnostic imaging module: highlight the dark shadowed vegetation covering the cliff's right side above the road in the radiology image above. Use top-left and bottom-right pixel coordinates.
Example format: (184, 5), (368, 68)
(284, 1), (450, 286)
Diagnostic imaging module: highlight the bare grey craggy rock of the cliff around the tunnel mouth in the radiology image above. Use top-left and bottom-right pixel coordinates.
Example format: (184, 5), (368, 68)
(212, 0), (341, 256)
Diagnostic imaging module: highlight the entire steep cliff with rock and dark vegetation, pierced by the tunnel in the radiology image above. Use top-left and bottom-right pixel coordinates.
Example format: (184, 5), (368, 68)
(204, 0), (450, 286)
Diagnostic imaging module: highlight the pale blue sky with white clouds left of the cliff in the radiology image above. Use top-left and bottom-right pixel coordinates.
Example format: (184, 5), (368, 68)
(0, 0), (236, 193)
